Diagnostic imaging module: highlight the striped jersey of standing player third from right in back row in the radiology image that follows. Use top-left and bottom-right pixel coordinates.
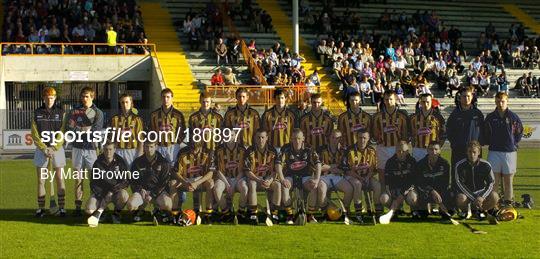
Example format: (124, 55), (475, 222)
(409, 109), (446, 148)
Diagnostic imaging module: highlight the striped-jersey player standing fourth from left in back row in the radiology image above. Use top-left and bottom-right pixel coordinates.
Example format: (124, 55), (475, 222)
(150, 88), (186, 164)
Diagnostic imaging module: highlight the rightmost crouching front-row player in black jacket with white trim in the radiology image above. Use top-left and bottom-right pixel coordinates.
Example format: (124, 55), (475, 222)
(454, 141), (499, 220)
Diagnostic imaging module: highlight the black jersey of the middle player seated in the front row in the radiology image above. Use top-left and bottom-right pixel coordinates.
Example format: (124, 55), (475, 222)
(277, 144), (321, 177)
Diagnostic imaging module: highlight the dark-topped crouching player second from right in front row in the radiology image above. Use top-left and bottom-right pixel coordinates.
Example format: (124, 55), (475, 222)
(414, 141), (450, 222)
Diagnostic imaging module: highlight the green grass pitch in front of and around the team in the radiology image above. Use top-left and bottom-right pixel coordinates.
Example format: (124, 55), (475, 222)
(0, 149), (540, 258)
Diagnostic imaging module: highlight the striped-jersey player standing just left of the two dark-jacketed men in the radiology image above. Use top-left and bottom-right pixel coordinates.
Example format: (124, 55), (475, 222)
(409, 93), (446, 161)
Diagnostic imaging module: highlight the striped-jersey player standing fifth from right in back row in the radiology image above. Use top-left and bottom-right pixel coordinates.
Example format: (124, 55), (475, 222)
(337, 92), (372, 149)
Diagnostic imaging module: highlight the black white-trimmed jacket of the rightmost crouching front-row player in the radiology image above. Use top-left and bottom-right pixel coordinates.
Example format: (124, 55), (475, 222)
(454, 159), (495, 201)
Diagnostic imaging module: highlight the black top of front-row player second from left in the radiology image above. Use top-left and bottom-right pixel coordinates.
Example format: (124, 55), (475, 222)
(130, 152), (171, 197)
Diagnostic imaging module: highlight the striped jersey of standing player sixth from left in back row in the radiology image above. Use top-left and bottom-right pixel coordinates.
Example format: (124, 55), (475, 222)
(225, 105), (260, 147)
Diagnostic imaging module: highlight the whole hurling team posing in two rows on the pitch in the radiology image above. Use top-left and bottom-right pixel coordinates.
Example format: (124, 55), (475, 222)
(32, 84), (523, 227)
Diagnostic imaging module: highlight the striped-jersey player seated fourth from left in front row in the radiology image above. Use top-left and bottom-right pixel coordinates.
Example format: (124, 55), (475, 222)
(214, 138), (248, 221)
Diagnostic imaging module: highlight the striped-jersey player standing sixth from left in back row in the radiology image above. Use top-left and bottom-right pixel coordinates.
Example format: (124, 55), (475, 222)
(225, 87), (260, 148)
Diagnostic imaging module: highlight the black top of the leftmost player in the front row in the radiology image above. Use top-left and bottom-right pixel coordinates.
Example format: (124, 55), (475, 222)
(90, 154), (129, 198)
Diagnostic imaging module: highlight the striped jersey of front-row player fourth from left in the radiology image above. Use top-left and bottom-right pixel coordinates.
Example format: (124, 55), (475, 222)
(216, 144), (246, 178)
